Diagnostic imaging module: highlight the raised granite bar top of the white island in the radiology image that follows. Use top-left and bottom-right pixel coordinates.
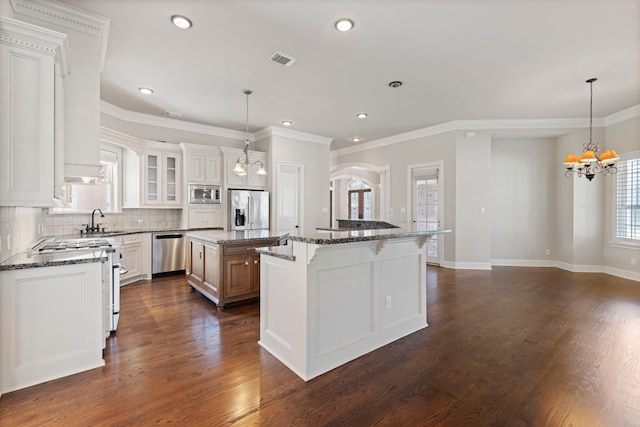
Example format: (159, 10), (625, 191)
(288, 228), (452, 245)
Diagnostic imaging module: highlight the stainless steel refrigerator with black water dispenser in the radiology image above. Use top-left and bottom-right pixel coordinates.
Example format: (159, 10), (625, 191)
(227, 190), (269, 230)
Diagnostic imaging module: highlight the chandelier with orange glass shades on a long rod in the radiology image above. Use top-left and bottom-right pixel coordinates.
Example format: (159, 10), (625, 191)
(564, 78), (620, 181)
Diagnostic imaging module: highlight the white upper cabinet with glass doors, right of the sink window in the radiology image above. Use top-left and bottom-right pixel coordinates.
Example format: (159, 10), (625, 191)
(123, 150), (183, 208)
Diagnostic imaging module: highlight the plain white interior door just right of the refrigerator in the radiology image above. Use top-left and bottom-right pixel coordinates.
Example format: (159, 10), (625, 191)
(276, 162), (304, 235)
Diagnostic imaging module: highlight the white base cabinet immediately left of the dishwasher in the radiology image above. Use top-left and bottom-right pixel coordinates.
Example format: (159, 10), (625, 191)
(116, 233), (151, 285)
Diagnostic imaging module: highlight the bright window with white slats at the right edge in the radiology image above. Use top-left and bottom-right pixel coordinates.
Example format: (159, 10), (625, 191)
(615, 158), (640, 241)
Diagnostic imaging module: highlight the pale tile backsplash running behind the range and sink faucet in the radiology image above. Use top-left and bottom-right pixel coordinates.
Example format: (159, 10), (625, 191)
(0, 207), (182, 262)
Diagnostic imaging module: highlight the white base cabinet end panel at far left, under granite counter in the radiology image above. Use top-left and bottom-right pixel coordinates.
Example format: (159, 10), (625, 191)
(0, 262), (104, 395)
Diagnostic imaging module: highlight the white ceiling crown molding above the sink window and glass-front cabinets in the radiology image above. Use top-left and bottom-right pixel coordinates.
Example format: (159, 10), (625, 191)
(100, 100), (249, 141)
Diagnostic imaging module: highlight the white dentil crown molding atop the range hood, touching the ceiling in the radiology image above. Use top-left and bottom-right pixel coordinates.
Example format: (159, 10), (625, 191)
(11, 0), (111, 70)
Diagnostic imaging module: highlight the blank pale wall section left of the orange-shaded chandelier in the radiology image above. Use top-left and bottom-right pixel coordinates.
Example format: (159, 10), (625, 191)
(491, 138), (562, 266)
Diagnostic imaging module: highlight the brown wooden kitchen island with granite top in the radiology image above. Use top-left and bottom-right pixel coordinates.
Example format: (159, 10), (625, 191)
(187, 230), (286, 310)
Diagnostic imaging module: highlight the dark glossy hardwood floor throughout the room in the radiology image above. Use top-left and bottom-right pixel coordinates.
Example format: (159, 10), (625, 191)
(0, 267), (640, 427)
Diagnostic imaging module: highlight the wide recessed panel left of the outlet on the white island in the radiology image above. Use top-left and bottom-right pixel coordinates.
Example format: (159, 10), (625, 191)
(313, 262), (375, 357)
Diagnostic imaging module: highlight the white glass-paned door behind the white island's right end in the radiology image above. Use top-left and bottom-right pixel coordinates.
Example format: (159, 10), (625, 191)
(411, 167), (442, 265)
